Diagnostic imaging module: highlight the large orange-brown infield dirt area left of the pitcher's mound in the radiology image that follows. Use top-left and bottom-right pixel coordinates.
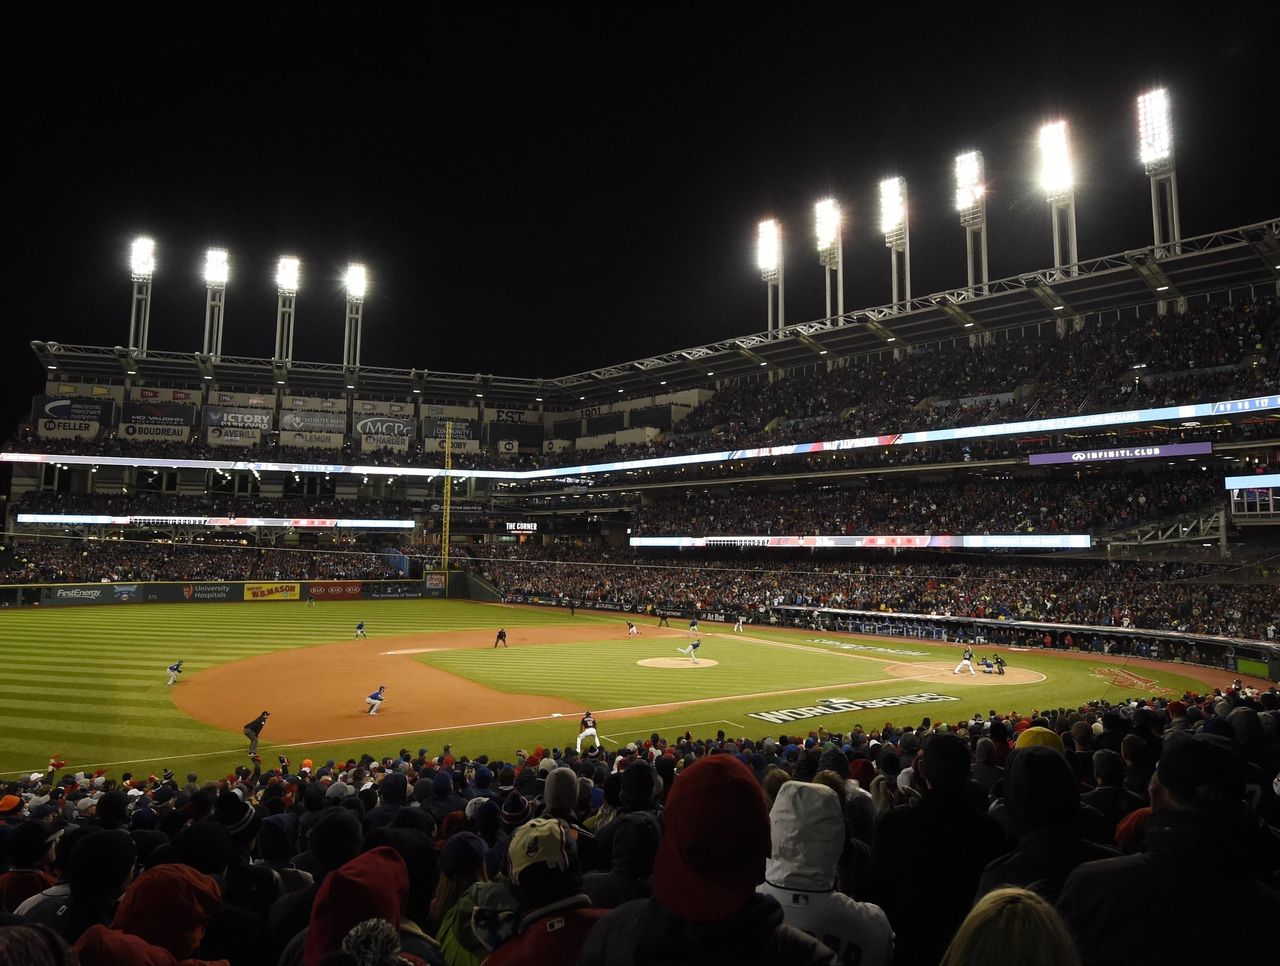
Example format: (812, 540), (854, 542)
(173, 627), (600, 747)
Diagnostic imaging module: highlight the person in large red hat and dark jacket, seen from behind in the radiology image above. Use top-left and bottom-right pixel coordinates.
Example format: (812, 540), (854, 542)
(579, 755), (837, 966)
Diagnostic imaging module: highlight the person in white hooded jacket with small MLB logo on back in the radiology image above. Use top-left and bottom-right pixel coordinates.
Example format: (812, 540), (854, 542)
(758, 782), (893, 966)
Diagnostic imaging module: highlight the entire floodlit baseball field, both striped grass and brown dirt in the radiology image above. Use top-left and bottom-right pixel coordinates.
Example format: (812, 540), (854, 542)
(0, 600), (1229, 778)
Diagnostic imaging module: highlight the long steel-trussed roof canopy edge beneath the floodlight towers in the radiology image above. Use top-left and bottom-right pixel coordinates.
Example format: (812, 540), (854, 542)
(32, 219), (1280, 407)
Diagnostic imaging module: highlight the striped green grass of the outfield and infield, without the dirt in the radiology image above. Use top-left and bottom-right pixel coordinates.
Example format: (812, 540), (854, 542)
(0, 600), (1213, 777)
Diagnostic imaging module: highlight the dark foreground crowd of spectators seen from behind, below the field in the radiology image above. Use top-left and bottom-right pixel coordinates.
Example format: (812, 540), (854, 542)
(0, 686), (1280, 966)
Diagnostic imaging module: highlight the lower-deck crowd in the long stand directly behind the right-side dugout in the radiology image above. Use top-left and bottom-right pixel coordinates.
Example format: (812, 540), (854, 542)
(470, 545), (1280, 640)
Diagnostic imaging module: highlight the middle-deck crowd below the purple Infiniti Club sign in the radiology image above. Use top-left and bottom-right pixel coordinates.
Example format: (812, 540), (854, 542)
(632, 464), (1224, 535)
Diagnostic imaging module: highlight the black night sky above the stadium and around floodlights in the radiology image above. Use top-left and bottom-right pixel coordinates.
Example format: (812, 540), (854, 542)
(0, 3), (1280, 432)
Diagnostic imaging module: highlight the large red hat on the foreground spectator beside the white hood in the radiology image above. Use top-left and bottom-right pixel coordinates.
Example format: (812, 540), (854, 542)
(652, 755), (771, 922)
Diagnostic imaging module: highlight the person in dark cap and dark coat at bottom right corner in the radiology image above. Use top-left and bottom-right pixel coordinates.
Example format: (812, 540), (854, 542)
(1057, 736), (1280, 966)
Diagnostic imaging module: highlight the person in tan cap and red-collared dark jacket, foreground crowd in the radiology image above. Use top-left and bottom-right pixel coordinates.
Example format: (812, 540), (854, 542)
(485, 818), (604, 966)
